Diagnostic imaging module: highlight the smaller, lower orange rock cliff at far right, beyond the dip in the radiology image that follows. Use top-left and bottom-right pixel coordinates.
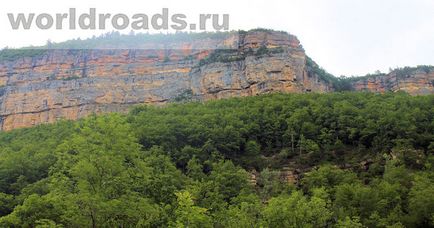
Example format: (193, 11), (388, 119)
(351, 67), (434, 95)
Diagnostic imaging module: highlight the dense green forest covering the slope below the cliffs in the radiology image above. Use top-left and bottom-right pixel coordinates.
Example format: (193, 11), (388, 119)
(0, 92), (434, 228)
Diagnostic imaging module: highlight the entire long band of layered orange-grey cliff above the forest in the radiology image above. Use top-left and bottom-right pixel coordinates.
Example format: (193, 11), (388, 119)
(0, 30), (434, 130)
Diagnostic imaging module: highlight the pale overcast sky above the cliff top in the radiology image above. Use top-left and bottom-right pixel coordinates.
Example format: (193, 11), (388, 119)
(0, 0), (434, 76)
